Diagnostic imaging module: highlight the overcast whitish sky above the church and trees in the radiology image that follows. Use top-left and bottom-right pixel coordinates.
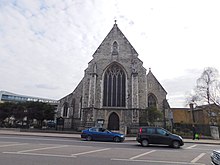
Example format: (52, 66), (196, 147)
(0, 0), (220, 108)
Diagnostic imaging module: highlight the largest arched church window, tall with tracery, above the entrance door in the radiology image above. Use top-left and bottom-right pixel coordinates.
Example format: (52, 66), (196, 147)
(103, 64), (126, 107)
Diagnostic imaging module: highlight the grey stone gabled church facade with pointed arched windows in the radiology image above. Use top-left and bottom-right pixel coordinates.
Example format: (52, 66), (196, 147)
(57, 23), (172, 132)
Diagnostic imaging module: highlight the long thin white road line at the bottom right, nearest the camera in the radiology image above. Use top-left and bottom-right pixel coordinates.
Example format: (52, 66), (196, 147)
(111, 159), (205, 165)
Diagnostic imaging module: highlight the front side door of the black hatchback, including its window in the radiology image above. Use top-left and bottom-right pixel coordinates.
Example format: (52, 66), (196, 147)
(156, 128), (171, 145)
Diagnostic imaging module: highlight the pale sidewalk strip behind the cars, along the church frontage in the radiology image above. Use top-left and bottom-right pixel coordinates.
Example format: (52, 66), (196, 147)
(0, 129), (220, 145)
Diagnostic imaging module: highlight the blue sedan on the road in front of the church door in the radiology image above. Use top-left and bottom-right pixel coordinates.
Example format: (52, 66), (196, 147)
(81, 127), (125, 142)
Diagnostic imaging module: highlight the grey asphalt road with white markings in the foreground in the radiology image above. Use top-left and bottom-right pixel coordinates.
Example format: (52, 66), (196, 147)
(0, 135), (217, 165)
